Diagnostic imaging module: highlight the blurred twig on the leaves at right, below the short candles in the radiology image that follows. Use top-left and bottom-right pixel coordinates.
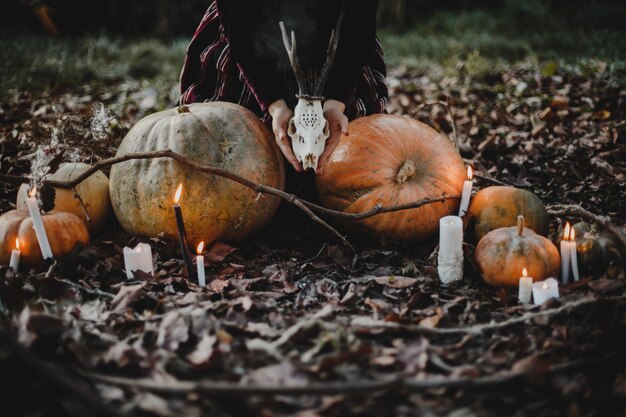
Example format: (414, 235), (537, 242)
(350, 295), (626, 335)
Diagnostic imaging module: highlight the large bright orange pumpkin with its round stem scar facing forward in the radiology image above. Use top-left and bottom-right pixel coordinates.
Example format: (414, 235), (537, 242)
(316, 114), (466, 242)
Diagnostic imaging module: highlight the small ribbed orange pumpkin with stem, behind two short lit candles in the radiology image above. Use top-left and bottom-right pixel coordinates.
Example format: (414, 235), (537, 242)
(474, 216), (561, 287)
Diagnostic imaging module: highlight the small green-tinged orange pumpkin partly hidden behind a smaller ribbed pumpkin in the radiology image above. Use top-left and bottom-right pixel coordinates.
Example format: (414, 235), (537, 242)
(463, 186), (550, 242)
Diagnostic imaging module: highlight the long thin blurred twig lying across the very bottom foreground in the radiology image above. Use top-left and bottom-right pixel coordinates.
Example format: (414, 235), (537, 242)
(79, 351), (624, 396)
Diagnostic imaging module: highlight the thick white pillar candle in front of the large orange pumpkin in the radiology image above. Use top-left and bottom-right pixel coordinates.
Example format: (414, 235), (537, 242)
(437, 216), (463, 284)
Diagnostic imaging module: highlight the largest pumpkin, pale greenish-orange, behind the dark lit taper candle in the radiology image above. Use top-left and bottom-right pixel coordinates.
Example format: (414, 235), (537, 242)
(110, 102), (285, 246)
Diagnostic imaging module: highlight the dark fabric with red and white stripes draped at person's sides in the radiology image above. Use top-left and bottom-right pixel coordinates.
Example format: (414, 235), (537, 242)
(180, 2), (388, 120)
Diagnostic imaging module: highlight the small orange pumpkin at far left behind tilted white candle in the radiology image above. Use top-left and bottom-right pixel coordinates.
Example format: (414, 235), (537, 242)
(0, 210), (89, 265)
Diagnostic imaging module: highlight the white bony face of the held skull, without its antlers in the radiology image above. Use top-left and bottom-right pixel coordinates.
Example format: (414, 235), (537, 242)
(287, 97), (330, 170)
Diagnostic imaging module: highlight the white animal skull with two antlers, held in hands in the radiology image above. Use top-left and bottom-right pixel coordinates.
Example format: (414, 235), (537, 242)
(279, 8), (344, 170)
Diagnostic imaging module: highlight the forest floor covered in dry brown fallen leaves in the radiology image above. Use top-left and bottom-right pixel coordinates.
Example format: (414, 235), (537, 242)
(0, 30), (626, 417)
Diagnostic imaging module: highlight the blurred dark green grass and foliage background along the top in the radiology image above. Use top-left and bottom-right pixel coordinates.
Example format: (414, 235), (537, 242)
(0, 0), (626, 99)
